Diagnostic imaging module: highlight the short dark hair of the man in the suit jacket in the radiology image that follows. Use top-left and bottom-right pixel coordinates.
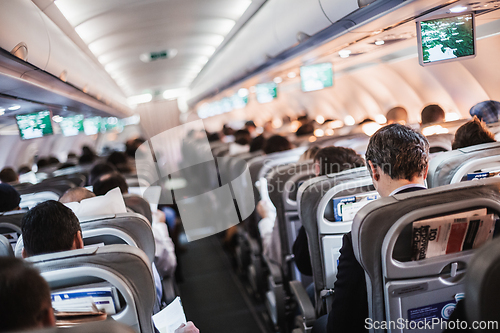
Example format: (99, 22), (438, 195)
(365, 124), (429, 180)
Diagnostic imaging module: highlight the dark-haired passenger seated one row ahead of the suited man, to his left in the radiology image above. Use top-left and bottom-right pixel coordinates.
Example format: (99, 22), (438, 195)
(293, 147), (365, 276)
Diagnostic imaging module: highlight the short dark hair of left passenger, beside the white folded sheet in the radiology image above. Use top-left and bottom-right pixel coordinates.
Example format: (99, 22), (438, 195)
(21, 200), (81, 256)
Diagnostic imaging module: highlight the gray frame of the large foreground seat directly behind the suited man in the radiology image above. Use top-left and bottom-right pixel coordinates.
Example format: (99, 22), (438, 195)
(352, 178), (500, 332)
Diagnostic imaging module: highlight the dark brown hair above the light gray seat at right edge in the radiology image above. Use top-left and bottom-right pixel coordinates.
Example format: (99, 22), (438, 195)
(451, 116), (496, 149)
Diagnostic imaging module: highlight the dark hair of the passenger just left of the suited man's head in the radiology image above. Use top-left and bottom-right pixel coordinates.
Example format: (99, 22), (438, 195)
(314, 146), (365, 176)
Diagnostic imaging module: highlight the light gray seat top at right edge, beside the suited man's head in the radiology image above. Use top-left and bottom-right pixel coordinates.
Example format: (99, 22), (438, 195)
(427, 142), (500, 188)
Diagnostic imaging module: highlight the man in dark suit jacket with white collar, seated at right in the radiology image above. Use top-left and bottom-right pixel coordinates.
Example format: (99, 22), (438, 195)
(314, 124), (429, 333)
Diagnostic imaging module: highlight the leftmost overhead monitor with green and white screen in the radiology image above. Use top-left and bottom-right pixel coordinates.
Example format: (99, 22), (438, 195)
(16, 110), (54, 140)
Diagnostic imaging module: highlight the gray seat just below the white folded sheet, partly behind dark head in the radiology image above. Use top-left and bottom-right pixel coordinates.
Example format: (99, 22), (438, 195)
(14, 213), (155, 263)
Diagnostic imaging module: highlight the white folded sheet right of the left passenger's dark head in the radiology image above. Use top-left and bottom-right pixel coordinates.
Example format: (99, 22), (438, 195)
(65, 187), (127, 221)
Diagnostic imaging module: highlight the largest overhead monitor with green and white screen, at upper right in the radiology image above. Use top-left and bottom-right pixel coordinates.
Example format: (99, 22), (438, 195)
(417, 13), (476, 66)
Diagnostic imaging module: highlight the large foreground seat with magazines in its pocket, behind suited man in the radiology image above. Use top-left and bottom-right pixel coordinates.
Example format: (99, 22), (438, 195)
(352, 179), (500, 332)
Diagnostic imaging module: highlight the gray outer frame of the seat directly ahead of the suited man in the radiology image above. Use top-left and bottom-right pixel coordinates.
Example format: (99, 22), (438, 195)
(297, 167), (373, 315)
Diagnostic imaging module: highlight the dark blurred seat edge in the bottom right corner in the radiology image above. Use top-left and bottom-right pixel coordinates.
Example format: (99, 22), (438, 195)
(464, 238), (500, 332)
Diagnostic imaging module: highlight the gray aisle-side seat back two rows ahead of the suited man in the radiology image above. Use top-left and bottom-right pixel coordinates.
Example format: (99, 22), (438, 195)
(267, 160), (315, 280)
